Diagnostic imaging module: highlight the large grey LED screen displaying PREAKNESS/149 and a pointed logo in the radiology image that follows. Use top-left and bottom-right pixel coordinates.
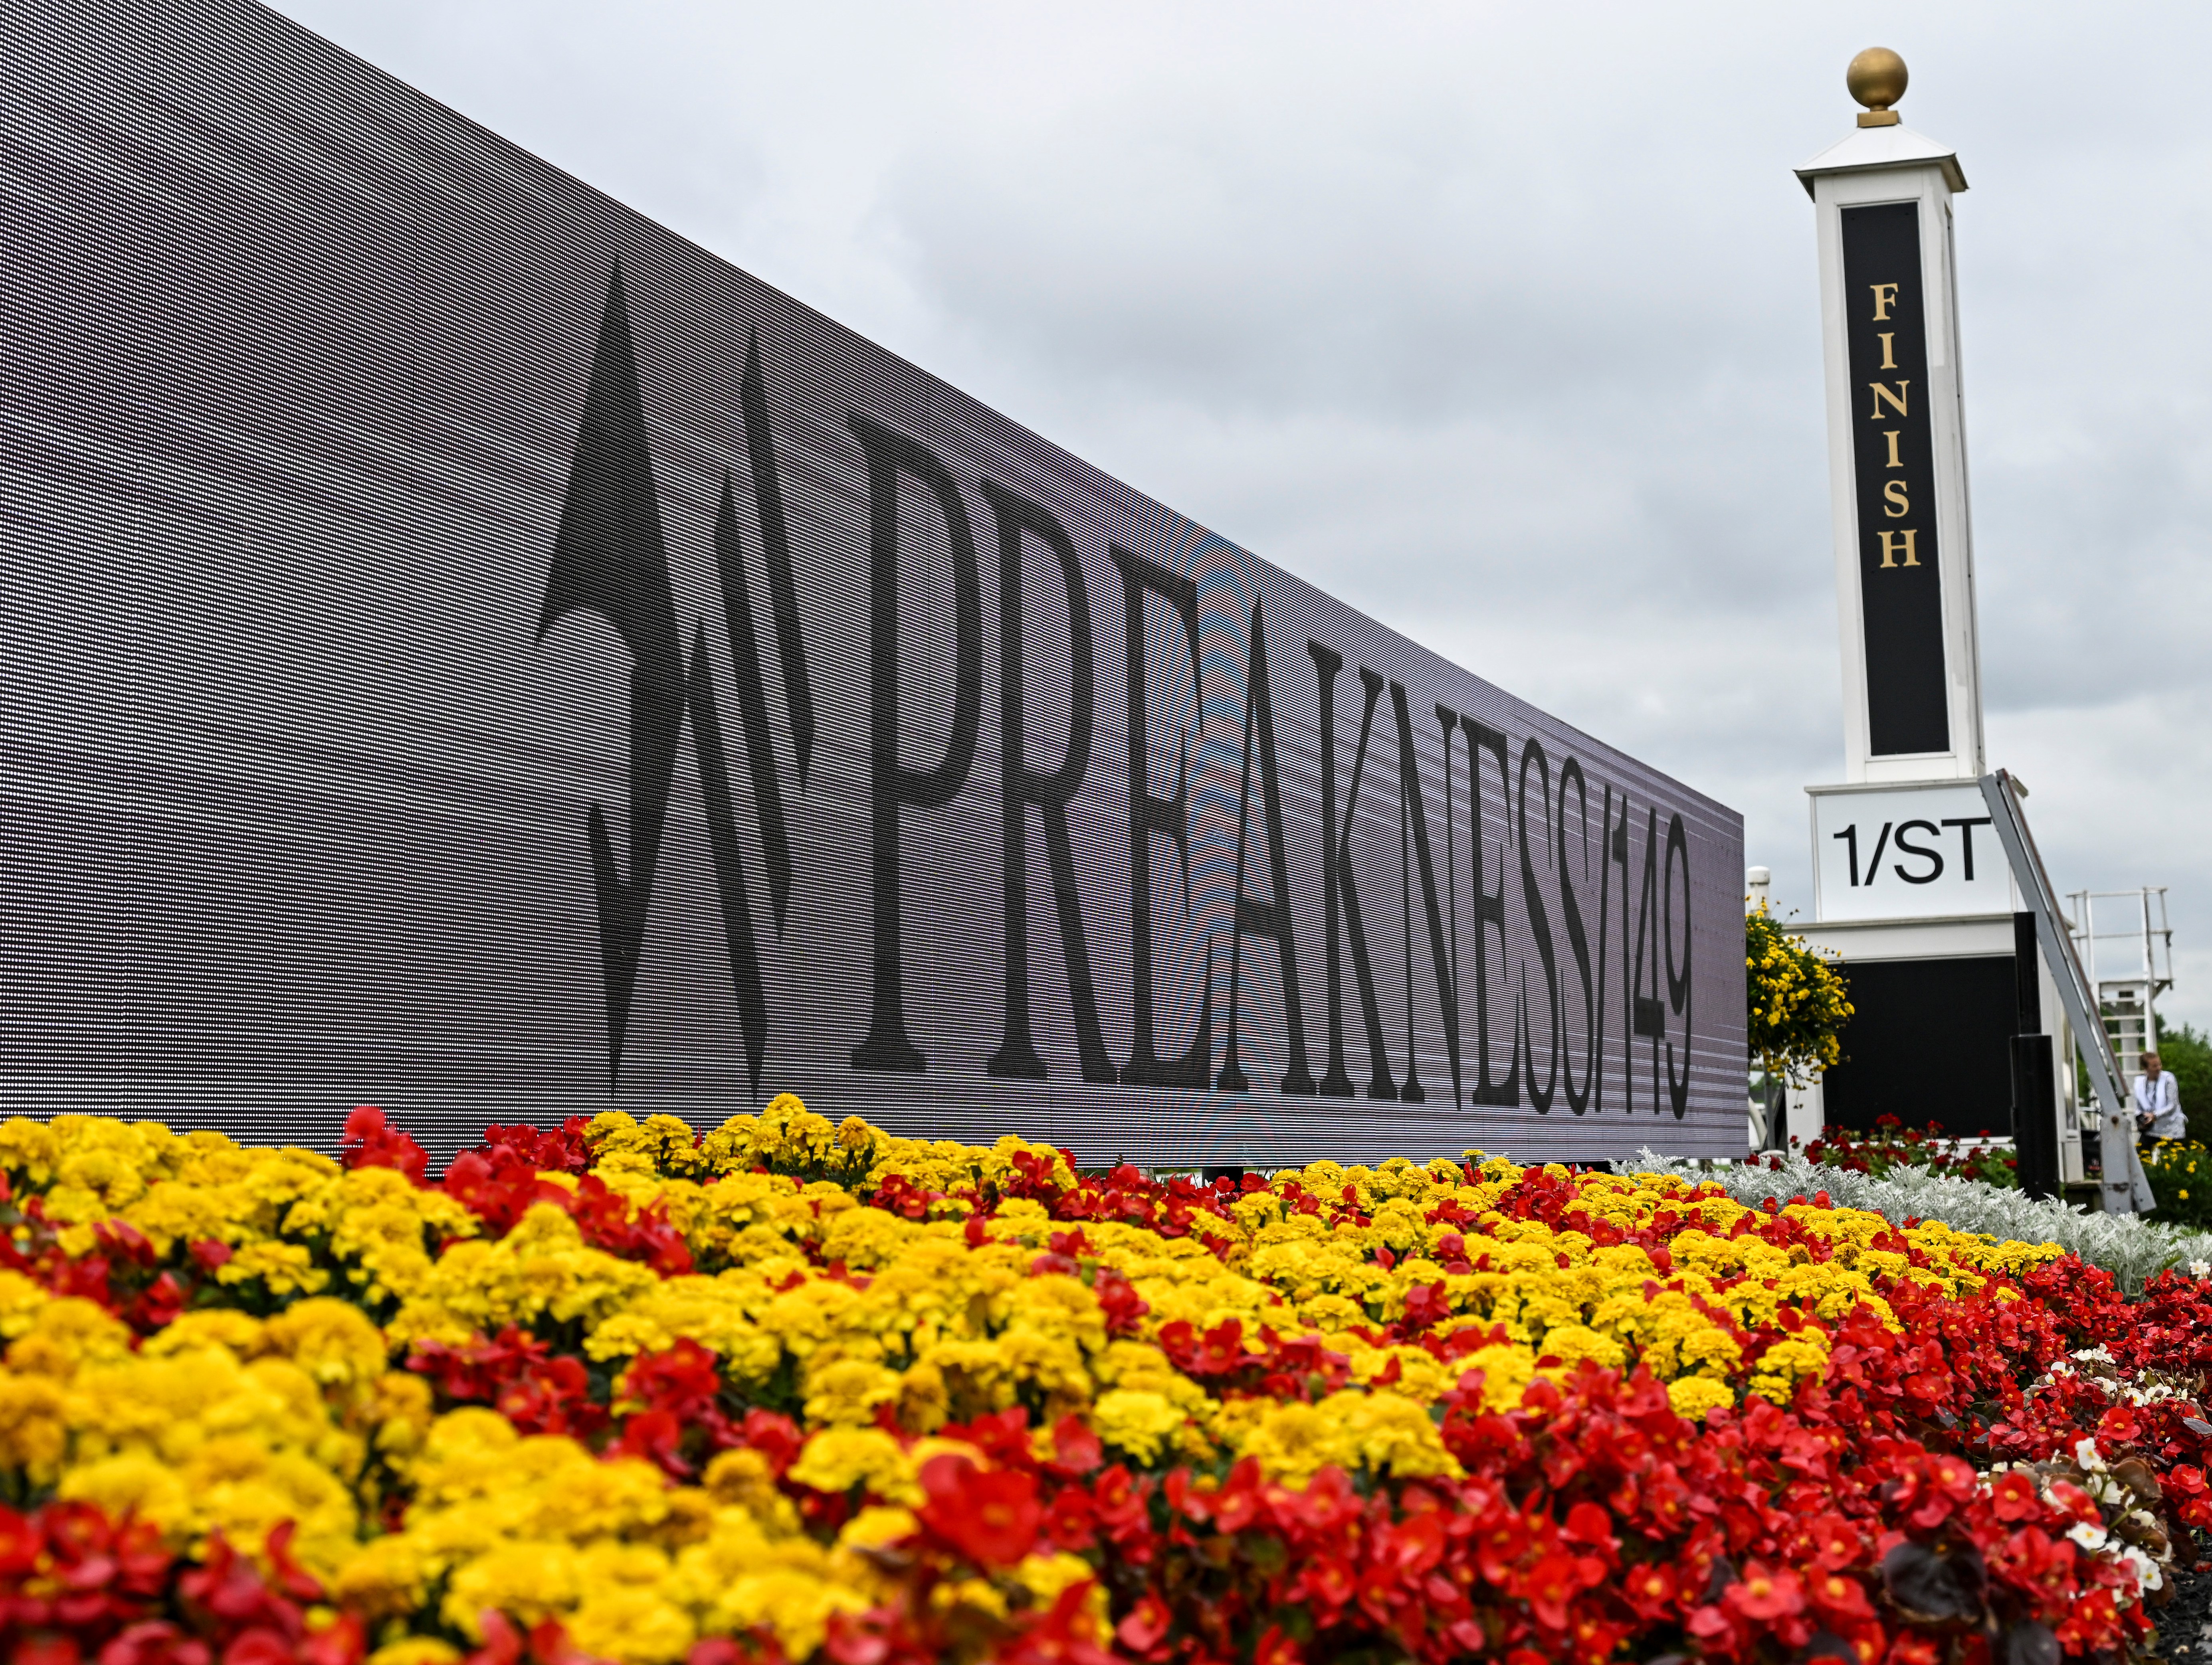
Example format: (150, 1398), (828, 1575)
(0, 0), (1745, 1165)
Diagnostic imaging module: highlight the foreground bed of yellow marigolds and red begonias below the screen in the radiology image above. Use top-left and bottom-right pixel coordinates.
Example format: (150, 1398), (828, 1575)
(0, 1099), (2212, 1665)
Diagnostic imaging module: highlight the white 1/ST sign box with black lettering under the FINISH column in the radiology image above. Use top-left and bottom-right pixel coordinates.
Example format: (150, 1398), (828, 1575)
(1812, 781), (2015, 920)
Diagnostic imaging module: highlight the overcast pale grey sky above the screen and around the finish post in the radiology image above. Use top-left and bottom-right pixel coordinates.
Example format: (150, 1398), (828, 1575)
(279, 0), (2212, 1024)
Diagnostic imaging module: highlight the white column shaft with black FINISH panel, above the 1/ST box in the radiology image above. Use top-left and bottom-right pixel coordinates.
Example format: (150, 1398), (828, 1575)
(1796, 76), (1984, 783)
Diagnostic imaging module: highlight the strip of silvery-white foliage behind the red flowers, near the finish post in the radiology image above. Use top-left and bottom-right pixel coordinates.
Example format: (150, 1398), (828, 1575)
(1635, 1150), (2212, 1293)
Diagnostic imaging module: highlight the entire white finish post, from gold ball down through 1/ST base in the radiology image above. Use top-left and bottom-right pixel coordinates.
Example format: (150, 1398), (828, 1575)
(1790, 46), (2020, 1185)
